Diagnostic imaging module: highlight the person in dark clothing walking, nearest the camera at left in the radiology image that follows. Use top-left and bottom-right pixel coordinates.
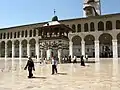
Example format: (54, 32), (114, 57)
(24, 57), (35, 78)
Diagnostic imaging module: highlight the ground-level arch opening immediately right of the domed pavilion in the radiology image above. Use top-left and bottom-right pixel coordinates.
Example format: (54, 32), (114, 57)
(72, 35), (81, 58)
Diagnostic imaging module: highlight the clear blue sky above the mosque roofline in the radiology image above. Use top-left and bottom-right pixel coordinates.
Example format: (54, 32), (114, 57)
(0, 0), (120, 28)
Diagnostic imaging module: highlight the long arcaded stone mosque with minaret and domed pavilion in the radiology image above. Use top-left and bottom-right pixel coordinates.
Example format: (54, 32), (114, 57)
(0, 0), (120, 60)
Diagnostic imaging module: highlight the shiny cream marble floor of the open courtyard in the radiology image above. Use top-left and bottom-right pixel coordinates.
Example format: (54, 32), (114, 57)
(0, 59), (120, 90)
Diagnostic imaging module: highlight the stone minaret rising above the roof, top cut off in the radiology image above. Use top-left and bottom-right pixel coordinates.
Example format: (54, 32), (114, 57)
(83, 0), (101, 17)
